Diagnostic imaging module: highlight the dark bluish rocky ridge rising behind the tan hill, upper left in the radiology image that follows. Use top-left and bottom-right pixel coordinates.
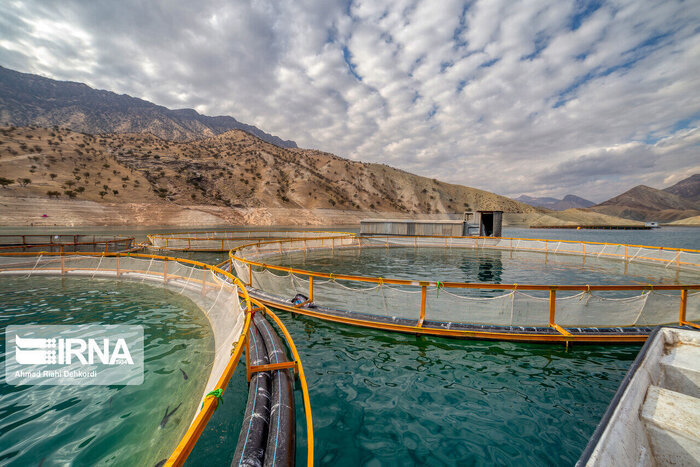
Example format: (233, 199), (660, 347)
(0, 67), (297, 148)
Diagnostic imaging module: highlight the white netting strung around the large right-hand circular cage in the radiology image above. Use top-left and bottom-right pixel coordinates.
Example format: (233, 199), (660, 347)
(232, 236), (700, 327)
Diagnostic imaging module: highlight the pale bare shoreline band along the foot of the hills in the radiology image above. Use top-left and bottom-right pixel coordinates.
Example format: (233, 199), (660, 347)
(0, 194), (700, 229)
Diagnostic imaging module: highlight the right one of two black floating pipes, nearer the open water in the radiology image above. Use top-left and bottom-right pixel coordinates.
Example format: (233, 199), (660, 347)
(253, 314), (296, 466)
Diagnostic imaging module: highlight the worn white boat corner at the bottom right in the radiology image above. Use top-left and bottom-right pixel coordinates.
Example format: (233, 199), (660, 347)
(576, 327), (700, 466)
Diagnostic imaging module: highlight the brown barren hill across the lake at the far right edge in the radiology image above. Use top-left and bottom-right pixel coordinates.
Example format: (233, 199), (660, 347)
(589, 185), (700, 222)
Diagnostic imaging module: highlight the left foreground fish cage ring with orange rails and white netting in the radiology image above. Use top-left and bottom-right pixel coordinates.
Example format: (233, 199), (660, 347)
(0, 252), (313, 465)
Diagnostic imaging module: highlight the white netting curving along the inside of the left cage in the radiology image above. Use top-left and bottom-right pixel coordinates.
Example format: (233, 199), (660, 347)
(0, 255), (245, 432)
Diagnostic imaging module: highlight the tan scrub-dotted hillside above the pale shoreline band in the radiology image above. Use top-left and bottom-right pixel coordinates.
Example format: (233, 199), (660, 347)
(0, 127), (537, 220)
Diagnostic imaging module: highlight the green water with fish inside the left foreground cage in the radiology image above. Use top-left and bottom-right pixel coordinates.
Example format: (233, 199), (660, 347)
(0, 277), (214, 466)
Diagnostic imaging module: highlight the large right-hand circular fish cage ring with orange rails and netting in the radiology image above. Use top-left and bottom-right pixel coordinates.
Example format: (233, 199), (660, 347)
(230, 235), (700, 343)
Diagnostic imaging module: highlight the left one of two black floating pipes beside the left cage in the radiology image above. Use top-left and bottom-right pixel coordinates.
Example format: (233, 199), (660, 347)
(231, 326), (270, 466)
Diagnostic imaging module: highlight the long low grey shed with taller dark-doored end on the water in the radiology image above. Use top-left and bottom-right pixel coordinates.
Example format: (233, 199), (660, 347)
(360, 211), (503, 237)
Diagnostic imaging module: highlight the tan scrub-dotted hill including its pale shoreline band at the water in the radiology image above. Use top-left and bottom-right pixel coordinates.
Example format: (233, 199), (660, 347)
(0, 127), (644, 226)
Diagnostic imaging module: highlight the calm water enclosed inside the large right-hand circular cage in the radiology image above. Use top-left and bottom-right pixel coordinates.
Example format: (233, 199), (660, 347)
(265, 247), (700, 297)
